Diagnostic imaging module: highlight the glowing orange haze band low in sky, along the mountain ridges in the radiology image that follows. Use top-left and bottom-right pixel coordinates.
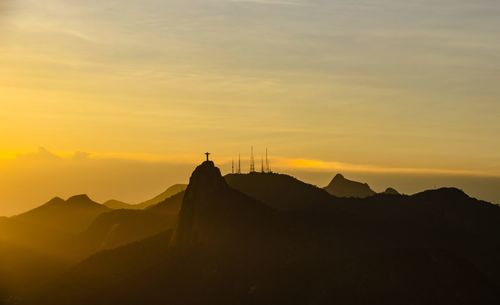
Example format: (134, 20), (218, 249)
(0, 148), (500, 216)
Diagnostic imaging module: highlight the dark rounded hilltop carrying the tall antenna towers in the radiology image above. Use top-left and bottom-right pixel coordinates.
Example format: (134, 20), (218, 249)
(224, 173), (332, 211)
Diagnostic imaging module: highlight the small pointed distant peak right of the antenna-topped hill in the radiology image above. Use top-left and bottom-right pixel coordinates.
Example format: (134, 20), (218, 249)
(325, 174), (376, 198)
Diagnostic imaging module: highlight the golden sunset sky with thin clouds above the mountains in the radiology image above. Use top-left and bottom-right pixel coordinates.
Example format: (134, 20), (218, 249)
(0, 0), (500, 215)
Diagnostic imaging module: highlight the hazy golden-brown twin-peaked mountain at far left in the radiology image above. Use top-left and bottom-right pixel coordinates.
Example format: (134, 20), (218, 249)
(12, 195), (110, 233)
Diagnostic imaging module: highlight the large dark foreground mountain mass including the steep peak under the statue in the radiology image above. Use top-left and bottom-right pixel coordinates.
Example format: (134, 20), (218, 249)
(33, 162), (500, 305)
